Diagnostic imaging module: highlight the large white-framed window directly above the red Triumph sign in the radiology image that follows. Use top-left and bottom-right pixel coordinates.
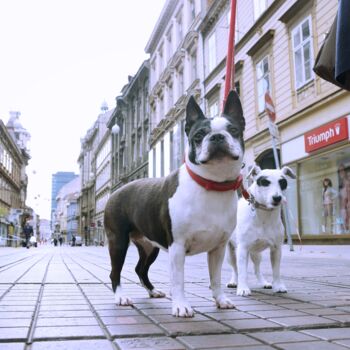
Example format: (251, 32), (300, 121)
(292, 17), (313, 89)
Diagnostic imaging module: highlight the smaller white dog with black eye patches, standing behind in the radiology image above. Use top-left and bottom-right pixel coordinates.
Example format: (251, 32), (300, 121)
(227, 165), (295, 296)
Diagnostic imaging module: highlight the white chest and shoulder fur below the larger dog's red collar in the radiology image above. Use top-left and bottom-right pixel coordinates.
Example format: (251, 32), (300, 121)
(169, 167), (237, 255)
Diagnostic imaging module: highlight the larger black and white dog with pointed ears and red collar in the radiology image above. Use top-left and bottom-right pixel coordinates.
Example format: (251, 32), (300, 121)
(104, 91), (245, 317)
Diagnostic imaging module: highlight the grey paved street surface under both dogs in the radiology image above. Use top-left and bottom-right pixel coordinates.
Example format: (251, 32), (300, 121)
(0, 246), (350, 350)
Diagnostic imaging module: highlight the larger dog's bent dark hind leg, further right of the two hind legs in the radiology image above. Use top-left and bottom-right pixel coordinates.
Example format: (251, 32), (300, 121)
(134, 240), (165, 298)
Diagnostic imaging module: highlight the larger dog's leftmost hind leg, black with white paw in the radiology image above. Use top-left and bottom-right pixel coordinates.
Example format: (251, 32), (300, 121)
(107, 228), (132, 305)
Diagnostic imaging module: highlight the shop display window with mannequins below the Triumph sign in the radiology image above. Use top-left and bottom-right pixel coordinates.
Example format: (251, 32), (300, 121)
(299, 147), (350, 235)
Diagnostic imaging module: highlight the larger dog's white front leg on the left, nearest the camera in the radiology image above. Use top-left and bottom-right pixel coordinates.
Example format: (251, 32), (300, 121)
(169, 243), (194, 317)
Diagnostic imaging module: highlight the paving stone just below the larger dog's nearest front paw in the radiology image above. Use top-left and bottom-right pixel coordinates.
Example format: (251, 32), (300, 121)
(160, 319), (231, 336)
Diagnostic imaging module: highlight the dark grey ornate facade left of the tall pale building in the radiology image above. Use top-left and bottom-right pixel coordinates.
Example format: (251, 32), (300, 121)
(108, 61), (150, 192)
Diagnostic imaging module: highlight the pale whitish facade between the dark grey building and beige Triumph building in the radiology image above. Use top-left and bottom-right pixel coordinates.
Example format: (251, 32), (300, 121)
(146, 0), (206, 177)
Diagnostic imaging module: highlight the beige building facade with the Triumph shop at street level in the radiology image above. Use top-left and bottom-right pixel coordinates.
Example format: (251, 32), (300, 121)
(200, 0), (350, 242)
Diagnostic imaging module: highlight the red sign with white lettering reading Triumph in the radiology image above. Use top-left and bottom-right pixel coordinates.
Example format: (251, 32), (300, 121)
(304, 117), (349, 153)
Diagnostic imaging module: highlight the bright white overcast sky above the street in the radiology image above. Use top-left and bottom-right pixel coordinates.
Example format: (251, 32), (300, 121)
(0, 0), (165, 219)
